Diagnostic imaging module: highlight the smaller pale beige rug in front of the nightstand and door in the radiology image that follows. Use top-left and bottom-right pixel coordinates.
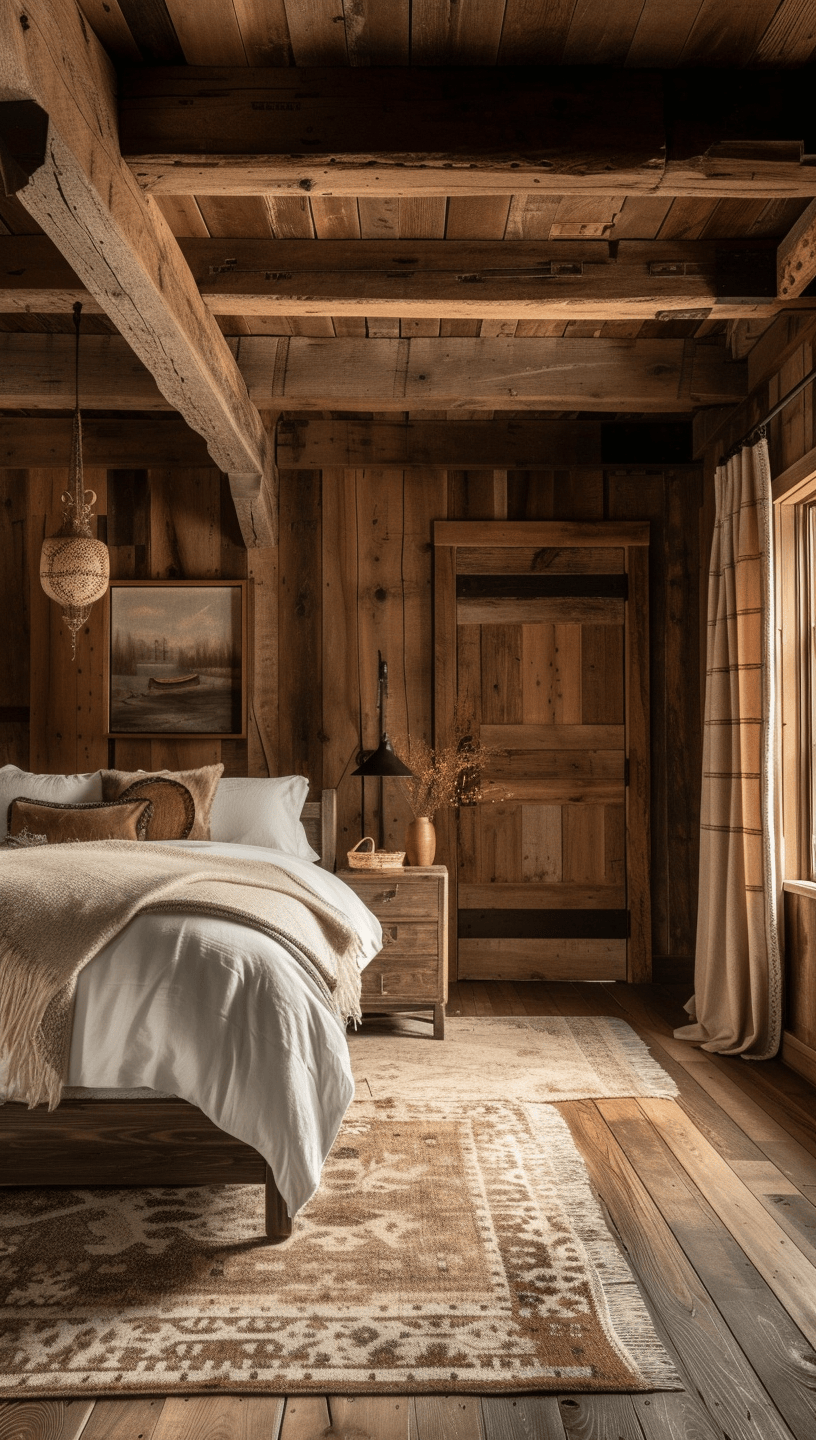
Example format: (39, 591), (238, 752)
(348, 1015), (678, 1104)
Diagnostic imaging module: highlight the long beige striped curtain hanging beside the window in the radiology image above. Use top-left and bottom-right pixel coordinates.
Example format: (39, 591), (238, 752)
(675, 438), (781, 1060)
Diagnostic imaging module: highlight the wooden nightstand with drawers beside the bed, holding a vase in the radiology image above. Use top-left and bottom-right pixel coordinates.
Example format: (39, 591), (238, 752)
(338, 865), (448, 1040)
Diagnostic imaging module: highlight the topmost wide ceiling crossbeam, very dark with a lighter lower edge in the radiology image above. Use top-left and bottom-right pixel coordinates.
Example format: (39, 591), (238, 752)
(119, 66), (816, 197)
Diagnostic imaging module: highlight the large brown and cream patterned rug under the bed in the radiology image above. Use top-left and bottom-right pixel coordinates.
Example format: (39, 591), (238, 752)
(0, 1100), (681, 1398)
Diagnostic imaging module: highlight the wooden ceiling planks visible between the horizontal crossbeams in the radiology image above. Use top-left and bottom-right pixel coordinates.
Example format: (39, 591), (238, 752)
(0, 0), (816, 371)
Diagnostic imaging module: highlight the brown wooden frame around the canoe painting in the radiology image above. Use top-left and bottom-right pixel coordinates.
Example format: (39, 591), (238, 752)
(105, 579), (249, 740)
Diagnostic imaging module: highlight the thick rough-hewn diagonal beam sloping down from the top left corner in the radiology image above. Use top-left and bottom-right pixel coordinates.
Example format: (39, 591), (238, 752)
(0, 0), (276, 544)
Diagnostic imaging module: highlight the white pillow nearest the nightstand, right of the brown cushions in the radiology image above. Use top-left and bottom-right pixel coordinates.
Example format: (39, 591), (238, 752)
(210, 775), (319, 860)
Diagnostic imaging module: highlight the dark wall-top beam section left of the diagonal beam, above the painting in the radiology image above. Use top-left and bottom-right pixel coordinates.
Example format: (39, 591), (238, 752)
(0, 415), (212, 469)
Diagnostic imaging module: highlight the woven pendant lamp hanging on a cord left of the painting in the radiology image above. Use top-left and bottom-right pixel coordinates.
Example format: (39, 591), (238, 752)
(40, 302), (111, 660)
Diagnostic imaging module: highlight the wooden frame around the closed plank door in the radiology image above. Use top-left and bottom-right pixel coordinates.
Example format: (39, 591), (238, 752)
(433, 520), (652, 984)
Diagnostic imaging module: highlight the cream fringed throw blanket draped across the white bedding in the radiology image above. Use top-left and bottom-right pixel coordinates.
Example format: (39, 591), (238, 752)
(0, 840), (360, 1109)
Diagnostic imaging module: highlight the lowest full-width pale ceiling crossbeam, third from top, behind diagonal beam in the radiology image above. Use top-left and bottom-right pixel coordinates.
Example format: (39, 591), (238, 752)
(0, 334), (745, 413)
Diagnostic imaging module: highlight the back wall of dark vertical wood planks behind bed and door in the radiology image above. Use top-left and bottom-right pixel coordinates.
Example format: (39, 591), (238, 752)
(0, 465), (701, 979)
